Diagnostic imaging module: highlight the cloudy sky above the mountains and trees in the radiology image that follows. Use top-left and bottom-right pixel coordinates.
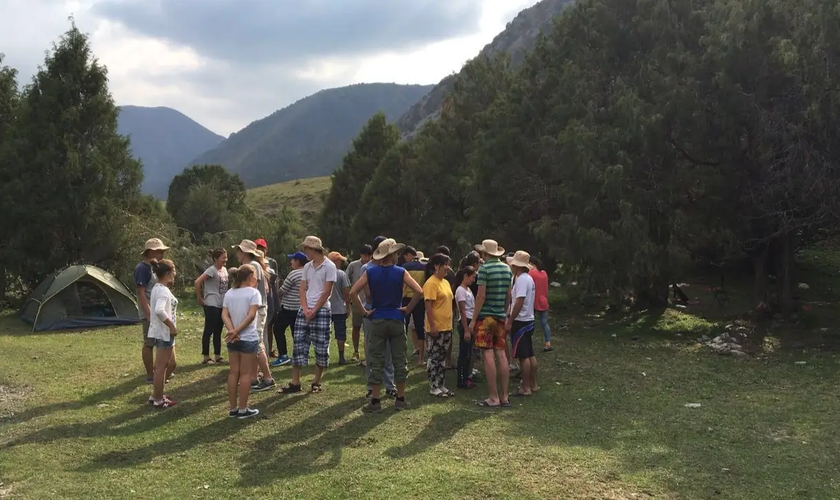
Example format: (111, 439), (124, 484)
(0, 0), (537, 136)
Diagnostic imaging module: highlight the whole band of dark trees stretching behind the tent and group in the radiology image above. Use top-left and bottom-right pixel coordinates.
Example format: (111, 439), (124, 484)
(0, 0), (840, 320)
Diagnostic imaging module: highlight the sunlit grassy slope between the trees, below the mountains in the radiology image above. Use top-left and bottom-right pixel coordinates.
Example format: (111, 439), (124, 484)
(246, 176), (330, 219)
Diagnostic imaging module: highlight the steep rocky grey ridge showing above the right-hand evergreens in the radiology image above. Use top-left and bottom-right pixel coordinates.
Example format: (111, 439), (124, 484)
(396, 0), (572, 137)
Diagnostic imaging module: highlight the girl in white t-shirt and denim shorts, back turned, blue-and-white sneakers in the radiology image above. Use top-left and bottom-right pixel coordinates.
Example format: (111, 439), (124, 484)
(222, 264), (262, 419)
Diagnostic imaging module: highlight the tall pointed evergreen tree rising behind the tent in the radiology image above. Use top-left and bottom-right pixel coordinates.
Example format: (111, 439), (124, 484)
(4, 24), (143, 284)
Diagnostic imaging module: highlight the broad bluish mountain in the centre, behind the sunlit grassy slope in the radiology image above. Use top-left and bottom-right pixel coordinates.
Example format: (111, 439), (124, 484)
(191, 83), (432, 188)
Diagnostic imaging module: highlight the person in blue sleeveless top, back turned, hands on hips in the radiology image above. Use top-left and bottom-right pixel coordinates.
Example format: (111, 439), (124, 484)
(350, 238), (423, 413)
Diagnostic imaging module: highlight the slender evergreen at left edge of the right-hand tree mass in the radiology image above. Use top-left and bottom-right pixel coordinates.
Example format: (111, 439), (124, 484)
(318, 113), (400, 250)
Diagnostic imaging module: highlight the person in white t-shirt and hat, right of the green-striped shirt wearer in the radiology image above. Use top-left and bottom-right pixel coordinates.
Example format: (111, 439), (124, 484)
(505, 250), (538, 396)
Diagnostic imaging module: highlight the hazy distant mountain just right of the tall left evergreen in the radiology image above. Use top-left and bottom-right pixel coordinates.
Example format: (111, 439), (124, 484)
(117, 106), (225, 199)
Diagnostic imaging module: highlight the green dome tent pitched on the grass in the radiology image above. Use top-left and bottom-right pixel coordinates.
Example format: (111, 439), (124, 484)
(20, 265), (140, 332)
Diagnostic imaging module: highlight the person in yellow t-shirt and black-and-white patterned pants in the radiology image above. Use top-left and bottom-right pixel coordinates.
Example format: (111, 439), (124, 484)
(423, 254), (454, 398)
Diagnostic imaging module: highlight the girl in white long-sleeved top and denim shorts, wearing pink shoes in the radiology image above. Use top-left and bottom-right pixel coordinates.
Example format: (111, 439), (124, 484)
(149, 259), (178, 410)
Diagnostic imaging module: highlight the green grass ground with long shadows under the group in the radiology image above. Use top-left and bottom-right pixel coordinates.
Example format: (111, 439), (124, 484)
(0, 301), (840, 499)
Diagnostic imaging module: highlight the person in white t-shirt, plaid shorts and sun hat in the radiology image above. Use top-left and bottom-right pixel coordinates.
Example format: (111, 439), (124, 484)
(278, 236), (337, 394)
